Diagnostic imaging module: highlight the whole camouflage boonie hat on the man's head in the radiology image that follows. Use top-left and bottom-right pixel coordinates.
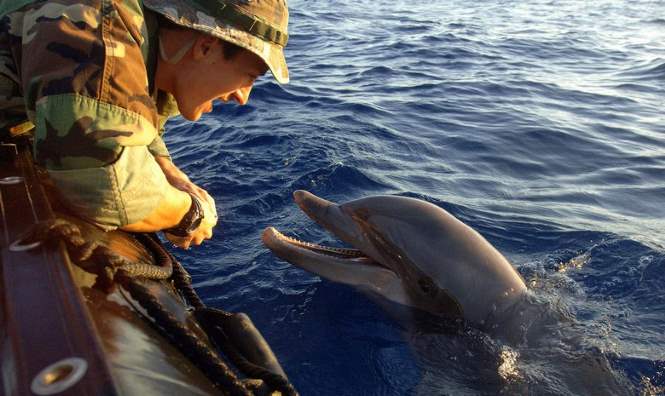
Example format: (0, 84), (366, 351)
(143, 0), (289, 84)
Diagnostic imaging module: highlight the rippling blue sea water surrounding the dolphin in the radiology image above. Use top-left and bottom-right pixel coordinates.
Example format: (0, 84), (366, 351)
(167, 0), (665, 395)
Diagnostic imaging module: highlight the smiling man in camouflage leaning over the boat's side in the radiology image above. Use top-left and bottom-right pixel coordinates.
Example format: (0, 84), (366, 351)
(0, 0), (289, 248)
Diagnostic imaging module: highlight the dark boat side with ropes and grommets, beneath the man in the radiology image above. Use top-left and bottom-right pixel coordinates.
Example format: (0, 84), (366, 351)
(0, 137), (296, 396)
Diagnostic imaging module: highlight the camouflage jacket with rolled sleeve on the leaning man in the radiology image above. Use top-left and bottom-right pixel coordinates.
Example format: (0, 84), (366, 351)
(0, 0), (177, 228)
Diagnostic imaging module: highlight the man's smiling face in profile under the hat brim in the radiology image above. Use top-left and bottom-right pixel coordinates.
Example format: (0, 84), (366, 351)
(172, 36), (268, 121)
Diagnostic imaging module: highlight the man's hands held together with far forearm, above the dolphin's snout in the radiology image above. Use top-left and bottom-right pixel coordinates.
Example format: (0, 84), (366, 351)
(155, 157), (217, 249)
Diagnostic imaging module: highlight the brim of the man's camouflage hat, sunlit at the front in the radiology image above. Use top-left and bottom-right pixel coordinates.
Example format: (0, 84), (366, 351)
(144, 0), (289, 84)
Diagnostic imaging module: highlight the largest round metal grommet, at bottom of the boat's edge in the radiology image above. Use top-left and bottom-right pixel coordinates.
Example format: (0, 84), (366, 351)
(30, 357), (88, 395)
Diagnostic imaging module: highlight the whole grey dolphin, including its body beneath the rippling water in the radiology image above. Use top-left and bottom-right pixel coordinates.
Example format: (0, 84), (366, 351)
(262, 191), (634, 395)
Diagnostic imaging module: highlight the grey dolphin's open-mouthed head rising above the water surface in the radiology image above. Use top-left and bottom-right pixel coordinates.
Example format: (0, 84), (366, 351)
(263, 191), (526, 322)
